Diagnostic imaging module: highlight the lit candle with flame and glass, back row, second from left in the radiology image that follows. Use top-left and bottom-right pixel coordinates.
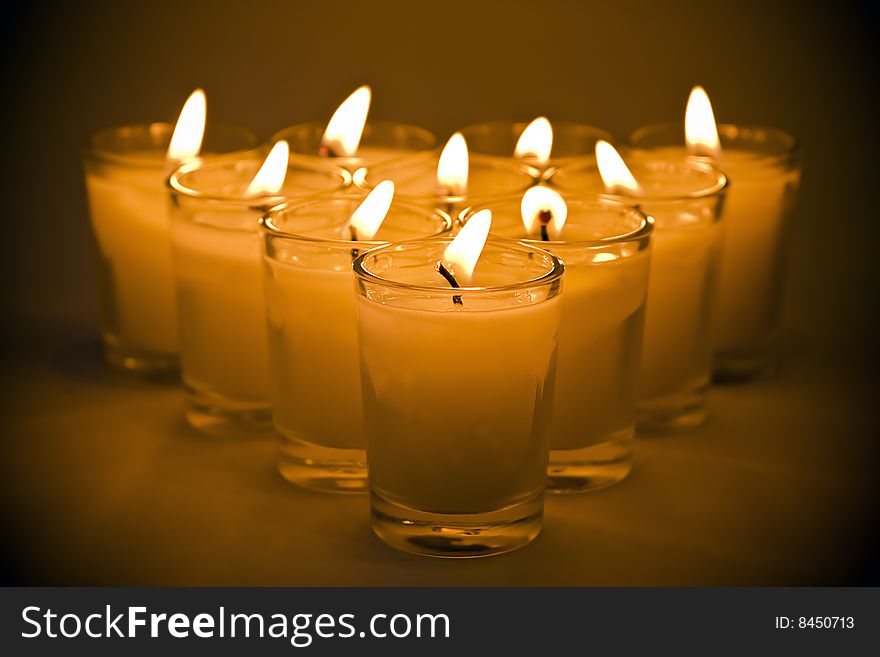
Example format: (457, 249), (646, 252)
(273, 85), (437, 177)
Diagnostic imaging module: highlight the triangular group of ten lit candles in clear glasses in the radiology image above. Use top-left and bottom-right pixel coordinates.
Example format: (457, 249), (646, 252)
(86, 80), (799, 556)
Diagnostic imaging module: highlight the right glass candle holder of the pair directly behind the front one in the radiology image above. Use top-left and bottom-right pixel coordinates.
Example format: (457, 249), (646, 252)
(464, 197), (653, 493)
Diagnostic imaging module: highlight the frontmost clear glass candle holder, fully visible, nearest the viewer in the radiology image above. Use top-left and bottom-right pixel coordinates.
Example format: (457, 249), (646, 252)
(354, 238), (563, 557)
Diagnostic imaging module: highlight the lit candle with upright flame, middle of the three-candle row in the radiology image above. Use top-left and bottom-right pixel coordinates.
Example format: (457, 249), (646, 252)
(360, 132), (533, 218)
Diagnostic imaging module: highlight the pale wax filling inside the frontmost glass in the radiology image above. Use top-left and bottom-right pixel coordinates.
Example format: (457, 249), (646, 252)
(358, 296), (561, 513)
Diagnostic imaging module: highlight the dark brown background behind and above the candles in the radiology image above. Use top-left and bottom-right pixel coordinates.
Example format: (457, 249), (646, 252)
(0, 0), (880, 583)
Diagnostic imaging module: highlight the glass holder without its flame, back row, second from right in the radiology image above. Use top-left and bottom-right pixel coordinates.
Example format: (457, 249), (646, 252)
(460, 121), (612, 182)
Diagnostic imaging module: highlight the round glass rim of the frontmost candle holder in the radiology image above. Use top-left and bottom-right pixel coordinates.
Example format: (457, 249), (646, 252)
(351, 234), (565, 296)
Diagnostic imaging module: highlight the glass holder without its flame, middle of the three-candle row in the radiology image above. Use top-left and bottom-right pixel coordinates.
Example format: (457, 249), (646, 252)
(358, 150), (534, 219)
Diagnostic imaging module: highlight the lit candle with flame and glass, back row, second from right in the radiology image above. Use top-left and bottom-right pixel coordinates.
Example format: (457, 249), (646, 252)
(461, 116), (611, 182)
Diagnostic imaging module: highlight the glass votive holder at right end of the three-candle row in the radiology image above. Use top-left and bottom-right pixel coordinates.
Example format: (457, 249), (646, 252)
(556, 154), (727, 431)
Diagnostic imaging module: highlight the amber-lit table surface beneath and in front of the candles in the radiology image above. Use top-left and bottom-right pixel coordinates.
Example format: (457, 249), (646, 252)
(2, 306), (876, 586)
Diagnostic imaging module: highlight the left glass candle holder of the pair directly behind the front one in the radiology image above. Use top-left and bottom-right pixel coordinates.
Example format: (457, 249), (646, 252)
(261, 194), (451, 492)
